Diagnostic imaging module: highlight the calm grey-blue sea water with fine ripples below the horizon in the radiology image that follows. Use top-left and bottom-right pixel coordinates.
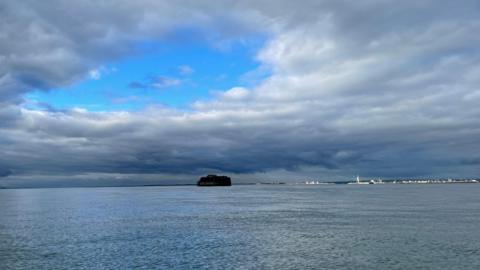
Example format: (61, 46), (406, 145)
(0, 184), (480, 269)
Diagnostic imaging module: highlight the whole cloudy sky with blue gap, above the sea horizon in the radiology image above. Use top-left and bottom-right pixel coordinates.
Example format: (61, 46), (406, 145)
(0, 0), (480, 187)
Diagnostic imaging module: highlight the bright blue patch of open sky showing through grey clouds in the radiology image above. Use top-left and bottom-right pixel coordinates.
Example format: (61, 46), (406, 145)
(26, 38), (268, 111)
